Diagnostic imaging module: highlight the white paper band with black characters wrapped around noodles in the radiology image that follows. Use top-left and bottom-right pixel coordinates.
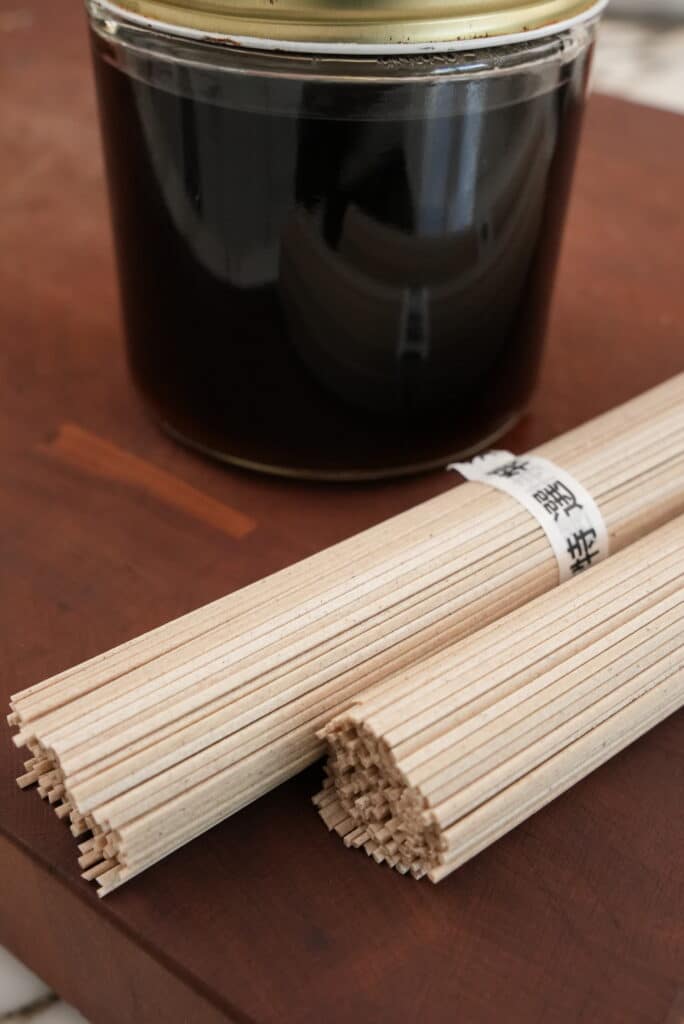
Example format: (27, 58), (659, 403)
(448, 452), (609, 583)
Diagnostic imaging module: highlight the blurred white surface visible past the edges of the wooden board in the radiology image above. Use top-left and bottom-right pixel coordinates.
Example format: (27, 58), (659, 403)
(0, 14), (684, 1024)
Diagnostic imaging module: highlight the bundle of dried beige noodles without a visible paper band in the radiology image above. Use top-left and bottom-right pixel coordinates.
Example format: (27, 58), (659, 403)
(315, 520), (684, 882)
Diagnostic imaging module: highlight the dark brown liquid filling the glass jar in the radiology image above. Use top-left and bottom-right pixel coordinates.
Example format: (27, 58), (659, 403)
(94, 37), (587, 476)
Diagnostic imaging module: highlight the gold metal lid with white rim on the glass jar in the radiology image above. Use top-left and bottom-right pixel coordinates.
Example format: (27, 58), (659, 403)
(99, 0), (607, 52)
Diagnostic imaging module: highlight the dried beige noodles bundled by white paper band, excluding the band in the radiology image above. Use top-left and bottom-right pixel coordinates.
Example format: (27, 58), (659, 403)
(9, 375), (684, 895)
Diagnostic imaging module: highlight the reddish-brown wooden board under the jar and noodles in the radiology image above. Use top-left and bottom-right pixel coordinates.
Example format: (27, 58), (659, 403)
(0, 0), (684, 1024)
